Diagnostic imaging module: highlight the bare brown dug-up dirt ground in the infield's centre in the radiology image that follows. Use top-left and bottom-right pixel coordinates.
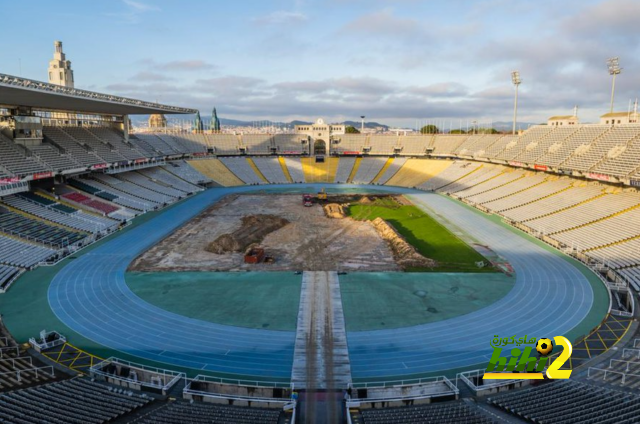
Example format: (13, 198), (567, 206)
(130, 194), (400, 271)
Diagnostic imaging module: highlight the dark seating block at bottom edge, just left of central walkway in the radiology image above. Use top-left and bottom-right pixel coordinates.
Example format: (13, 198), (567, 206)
(140, 401), (282, 424)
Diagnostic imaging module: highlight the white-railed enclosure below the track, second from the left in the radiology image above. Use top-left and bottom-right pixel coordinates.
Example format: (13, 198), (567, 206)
(89, 357), (186, 395)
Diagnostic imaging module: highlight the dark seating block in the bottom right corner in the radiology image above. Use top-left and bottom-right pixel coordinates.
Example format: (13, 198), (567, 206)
(487, 380), (640, 424)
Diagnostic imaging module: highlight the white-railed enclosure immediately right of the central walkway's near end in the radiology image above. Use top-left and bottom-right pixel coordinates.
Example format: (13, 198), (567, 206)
(347, 376), (460, 409)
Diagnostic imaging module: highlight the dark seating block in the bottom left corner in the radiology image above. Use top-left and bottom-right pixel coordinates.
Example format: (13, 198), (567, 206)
(0, 378), (152, 424)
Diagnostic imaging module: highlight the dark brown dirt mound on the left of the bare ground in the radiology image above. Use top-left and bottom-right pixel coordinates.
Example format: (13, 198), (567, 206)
(205, 215), (289, 254)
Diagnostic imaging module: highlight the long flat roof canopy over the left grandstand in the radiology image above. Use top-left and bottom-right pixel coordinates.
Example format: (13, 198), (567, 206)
(0, 73), (196, 115)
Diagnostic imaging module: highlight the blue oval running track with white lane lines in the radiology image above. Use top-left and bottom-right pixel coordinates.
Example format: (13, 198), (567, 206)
(48, 184), (593, 380)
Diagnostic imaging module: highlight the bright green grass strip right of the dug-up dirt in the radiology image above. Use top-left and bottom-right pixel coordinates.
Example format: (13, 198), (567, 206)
(347, 197), (495, 273)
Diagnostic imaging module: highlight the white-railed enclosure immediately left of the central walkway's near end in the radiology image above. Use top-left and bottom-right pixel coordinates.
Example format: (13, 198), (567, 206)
(182, 375), (296, 410)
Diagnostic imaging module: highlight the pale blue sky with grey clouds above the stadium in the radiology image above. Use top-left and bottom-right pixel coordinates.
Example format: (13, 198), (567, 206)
(0, 0), (640, 128)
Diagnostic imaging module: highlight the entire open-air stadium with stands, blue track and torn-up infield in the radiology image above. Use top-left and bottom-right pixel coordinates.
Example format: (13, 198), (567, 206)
(0, 6), (640, 424)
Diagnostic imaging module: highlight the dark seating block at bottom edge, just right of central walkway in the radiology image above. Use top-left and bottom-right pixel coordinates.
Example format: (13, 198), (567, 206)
(362, 402), (493, 424)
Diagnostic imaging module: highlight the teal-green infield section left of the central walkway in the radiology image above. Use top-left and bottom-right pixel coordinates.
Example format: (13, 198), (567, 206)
(125, 272), (302, 331)
